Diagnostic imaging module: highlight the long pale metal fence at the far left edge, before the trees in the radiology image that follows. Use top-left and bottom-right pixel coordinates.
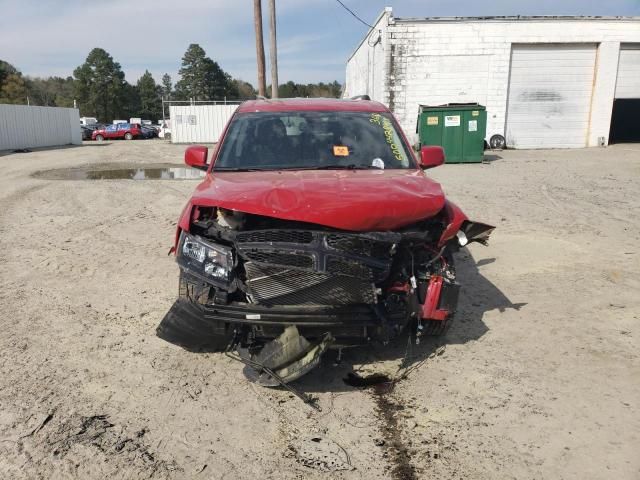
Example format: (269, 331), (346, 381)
(0, 105), (82, 150)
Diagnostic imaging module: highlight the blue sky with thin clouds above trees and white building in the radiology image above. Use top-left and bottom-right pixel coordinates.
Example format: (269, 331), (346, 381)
(0, 0), (640, 85)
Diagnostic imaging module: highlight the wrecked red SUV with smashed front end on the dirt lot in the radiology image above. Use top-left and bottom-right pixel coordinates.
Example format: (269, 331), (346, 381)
(157, 99), (493, 385)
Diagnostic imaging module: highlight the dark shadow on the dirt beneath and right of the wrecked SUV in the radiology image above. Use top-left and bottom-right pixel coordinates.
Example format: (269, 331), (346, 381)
(159, 249), (526, 393)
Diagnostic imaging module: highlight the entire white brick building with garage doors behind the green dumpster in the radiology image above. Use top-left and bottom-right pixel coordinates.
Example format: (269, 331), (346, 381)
(344, 7), (640, 148)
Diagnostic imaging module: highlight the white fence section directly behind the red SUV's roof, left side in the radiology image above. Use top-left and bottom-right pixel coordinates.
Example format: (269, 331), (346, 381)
(169, 104), (238, 143)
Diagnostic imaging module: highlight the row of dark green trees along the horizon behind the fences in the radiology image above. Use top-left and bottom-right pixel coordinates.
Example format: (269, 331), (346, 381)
(0, 44), (342, 122)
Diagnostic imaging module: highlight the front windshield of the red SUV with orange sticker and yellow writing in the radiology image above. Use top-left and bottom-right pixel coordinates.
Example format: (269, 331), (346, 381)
(213, 111), (413, 171)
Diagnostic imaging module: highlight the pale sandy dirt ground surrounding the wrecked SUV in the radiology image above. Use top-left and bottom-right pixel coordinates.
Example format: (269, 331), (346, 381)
(0, 141), (640, 480)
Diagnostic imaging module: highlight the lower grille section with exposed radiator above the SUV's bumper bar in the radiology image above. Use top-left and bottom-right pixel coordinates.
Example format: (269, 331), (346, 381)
(244, 262), (376, 305)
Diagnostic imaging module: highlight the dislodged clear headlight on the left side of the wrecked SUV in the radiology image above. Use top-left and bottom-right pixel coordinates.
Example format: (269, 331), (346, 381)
(178, 232), (233, 283)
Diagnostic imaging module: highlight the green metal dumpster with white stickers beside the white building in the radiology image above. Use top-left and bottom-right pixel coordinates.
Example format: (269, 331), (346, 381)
(417, 103), (487, 163)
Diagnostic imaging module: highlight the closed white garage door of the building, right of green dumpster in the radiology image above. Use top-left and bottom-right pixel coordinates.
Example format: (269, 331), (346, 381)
(506, 44), (596, 148)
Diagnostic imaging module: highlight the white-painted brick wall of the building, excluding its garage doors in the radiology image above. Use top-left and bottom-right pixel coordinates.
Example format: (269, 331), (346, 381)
(345, 9), (640, 146)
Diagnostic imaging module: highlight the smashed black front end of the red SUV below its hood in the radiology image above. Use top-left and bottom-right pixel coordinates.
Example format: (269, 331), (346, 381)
(158, 212), (491, 384)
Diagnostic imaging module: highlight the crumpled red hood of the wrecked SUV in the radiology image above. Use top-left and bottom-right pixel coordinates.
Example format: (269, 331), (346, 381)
(191, 169), (445, 231)
